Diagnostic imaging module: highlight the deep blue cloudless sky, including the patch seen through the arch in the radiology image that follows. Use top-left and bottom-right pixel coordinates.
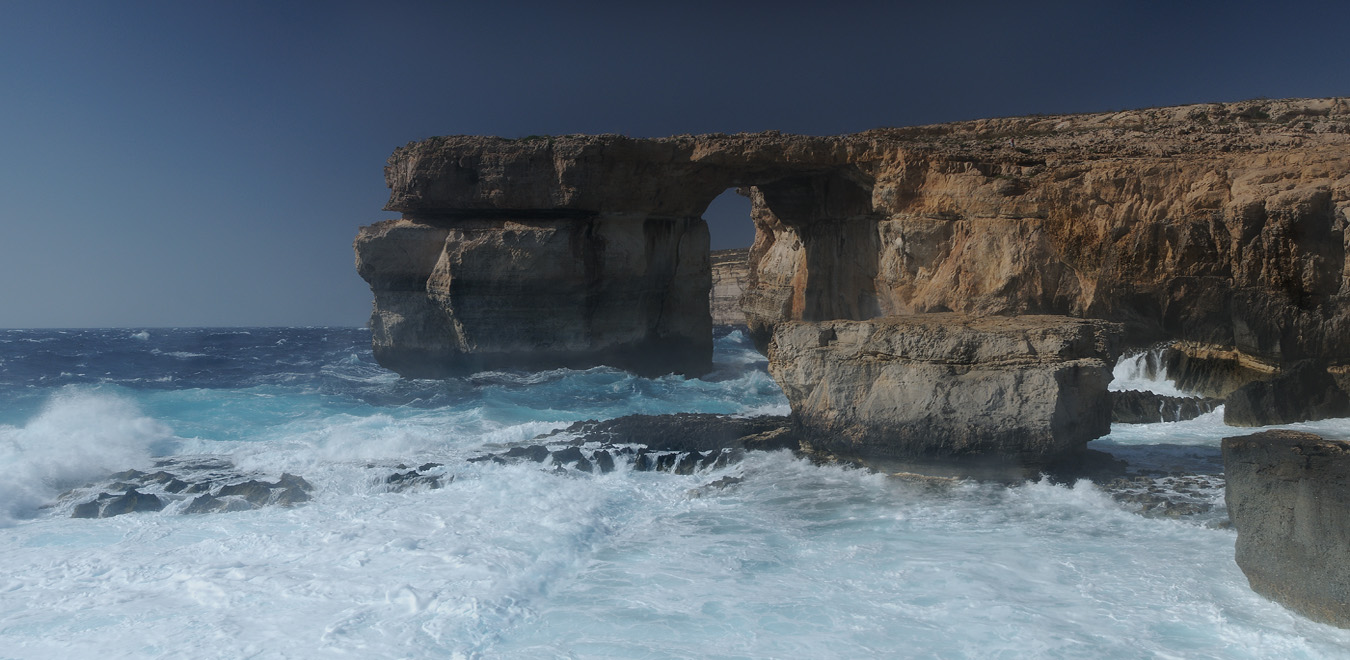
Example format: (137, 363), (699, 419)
(0, 0), (1350, 328)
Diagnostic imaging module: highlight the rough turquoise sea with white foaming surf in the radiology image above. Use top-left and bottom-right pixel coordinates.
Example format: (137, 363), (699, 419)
(0, 328), (1350, 659)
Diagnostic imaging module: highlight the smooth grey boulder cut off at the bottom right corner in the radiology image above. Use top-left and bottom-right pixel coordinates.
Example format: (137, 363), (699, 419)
(1223, 431), (1350, 628)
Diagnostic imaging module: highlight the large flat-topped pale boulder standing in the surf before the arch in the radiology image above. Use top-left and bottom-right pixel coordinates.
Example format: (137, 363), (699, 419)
(768, 313), (1119, 468)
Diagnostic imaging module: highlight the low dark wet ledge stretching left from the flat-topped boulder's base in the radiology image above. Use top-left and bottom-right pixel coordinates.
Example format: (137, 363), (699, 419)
(536, 413), (797, 452)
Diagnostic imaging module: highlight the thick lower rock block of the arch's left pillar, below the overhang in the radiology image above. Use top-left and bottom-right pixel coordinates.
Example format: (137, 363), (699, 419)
(356, 217), (711, 378)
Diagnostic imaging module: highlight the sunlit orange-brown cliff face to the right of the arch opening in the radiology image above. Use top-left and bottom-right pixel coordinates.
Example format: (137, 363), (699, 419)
(747, 100), (1350, 364)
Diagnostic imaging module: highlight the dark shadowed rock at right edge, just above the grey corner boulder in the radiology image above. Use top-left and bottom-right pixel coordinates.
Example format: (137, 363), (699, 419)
(1223, 360), (1350, 427)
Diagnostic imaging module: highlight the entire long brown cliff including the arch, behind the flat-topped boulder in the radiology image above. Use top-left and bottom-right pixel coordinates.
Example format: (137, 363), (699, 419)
(356, 99), (1350, 396)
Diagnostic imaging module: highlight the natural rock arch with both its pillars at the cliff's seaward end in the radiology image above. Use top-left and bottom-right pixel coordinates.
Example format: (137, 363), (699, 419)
(356, 135), (880, 377)
